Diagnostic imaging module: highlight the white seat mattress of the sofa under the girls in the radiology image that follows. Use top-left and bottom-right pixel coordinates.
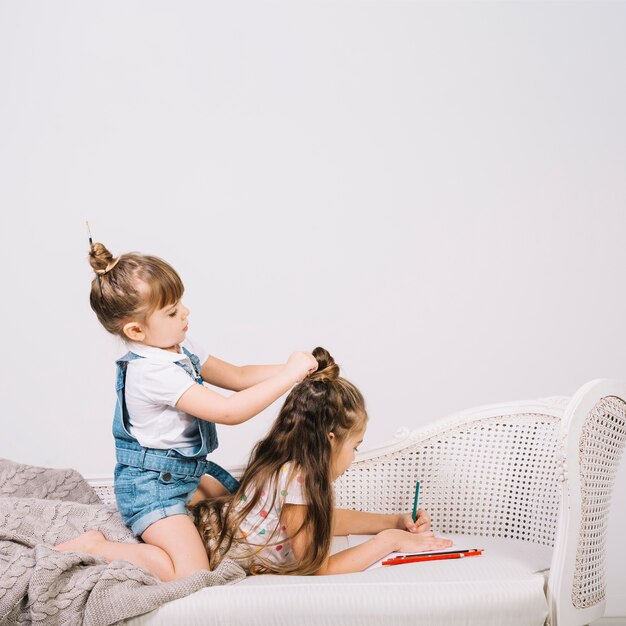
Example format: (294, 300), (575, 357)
(128, 536), (552, 626)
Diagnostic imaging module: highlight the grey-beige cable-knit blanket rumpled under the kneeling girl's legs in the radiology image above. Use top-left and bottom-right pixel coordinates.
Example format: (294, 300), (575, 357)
(0, 459), (245, 626)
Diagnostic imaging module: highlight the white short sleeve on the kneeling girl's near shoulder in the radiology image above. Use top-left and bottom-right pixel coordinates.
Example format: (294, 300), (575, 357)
(126, 359), (196, 406)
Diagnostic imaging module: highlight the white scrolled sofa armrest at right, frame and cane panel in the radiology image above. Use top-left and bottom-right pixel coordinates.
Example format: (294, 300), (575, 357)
(547, 380), (626, 626)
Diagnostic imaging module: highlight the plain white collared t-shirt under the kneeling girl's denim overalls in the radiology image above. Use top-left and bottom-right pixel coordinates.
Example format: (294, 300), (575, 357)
(125, 338), (209, 450)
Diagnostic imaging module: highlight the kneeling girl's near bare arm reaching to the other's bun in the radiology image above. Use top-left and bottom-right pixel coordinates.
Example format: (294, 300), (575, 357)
(176, 352), (317, 424)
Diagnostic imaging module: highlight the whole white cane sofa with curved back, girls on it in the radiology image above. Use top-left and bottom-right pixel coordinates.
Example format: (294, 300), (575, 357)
(89, 380), (626, 626)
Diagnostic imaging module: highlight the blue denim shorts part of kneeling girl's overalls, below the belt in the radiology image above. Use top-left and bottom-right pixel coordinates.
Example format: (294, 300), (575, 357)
(115, 463), (200, 537)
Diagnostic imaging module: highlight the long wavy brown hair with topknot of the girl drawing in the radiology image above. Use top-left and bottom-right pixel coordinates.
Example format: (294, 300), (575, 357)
(191, 348), (367, 575)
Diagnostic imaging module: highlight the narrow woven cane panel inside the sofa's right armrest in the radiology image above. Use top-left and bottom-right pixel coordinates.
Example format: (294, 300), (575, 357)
(572, 397), (626, 608)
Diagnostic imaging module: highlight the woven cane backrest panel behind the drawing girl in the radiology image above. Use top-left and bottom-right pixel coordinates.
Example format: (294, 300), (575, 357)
(335, 413), (562, 546)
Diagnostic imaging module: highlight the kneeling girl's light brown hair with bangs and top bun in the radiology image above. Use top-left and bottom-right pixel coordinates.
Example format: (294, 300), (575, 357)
(88, 242), (185, 339)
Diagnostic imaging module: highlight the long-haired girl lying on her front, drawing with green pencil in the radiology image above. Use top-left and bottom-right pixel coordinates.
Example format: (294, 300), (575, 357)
(191, 348), (452, 575)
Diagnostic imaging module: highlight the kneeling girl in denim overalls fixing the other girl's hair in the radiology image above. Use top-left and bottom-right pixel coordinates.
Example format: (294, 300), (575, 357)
(57, 237), (317, 580)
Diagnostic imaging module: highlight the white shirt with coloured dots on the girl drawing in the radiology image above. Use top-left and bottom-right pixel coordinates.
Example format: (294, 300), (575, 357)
(238, 463), (306, 564)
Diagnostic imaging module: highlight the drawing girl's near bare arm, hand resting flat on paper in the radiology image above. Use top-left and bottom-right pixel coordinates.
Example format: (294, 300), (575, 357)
(281, 504), (452, 575)
